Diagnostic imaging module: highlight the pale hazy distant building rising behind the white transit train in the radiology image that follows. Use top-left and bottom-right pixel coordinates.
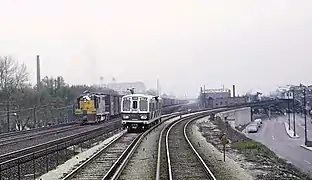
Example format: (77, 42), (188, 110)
(107, 81), (146, 94)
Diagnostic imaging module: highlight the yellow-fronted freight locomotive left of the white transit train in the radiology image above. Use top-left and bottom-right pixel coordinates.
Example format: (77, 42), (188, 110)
(74, 91), (121, 124)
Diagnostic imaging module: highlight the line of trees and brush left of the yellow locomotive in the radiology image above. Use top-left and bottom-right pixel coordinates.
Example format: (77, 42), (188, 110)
(0, 56), (116, 133)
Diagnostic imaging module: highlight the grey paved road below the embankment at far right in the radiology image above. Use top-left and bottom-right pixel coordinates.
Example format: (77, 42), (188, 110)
(243, 115), (312, 175)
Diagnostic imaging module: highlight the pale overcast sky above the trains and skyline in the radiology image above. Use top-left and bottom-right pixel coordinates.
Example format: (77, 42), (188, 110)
(0, 0), (312, 96)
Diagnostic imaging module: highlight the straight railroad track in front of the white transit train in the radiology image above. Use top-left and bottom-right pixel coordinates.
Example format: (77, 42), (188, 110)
(63, 115), (175, 180)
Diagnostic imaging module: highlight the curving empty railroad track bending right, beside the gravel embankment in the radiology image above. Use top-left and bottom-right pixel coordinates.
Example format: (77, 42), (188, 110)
(156, 114), (216, 180)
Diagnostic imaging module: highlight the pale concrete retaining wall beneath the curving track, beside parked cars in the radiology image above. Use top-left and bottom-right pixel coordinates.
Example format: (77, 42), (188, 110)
(216, 107), (251, 127)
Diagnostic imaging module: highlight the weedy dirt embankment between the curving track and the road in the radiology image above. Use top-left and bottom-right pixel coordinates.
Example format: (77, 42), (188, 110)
(197, 120), (312, 180)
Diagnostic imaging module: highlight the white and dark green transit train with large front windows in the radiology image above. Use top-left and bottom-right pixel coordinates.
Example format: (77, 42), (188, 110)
(121, 94), (162, 132)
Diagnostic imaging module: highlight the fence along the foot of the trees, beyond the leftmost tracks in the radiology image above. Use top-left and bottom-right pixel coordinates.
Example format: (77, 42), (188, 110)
(0, 105), (74, 133)
